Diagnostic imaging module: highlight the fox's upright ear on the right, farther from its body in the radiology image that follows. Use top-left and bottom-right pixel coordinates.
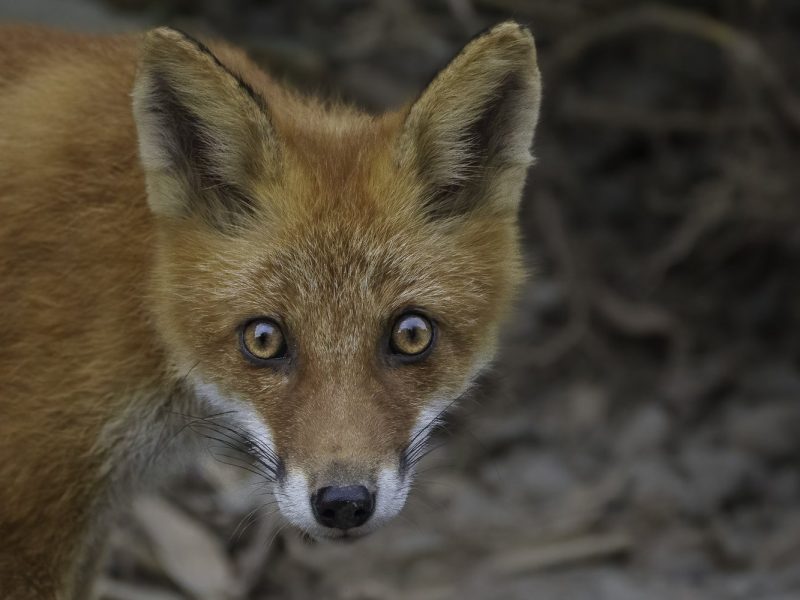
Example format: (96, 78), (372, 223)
(400, 22), (541, 216)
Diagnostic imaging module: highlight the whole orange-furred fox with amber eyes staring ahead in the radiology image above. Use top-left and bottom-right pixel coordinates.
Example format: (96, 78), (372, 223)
(0, 21), (541, 600)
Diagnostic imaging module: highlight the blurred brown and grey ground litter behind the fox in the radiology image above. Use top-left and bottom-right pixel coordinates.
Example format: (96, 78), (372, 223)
(0, 0), (800, 600)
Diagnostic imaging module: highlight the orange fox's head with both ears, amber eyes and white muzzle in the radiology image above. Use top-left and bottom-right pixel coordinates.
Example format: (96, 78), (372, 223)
(133, 23), (540, 538)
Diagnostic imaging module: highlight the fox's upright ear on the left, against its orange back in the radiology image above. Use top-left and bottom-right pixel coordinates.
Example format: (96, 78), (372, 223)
(133, 27), (279, 227)
